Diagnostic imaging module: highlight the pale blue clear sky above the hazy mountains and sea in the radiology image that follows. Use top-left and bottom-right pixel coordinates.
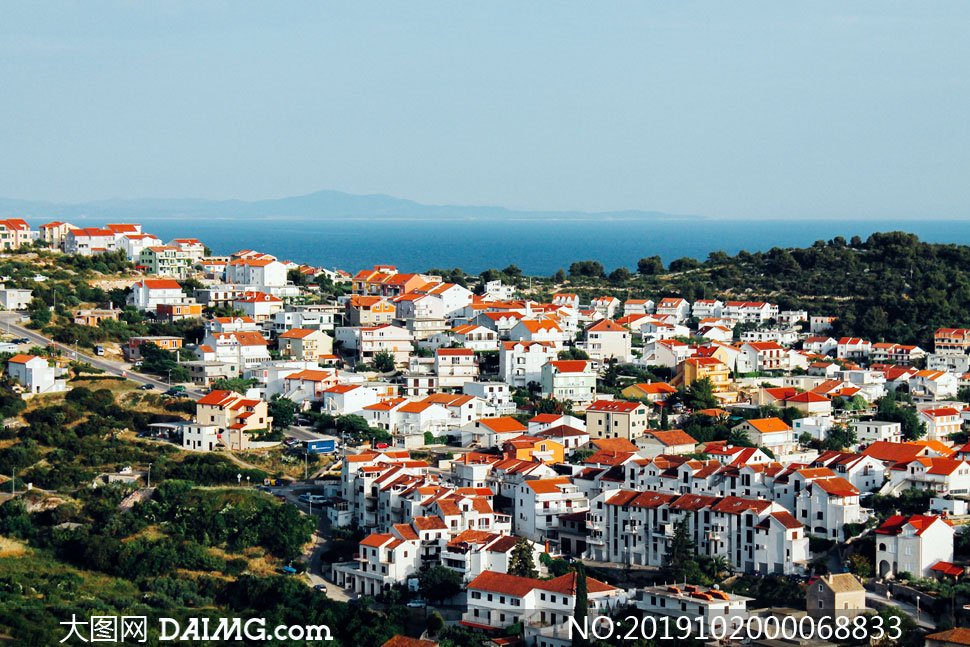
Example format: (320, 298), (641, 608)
(0, 0), (970, 218)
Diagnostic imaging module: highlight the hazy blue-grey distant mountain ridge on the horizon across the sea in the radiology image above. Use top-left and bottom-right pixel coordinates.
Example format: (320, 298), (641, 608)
(0, 191), (699, 224)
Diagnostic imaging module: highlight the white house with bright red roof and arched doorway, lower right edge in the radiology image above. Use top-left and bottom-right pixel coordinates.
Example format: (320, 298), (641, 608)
(876, 514), (953, 578)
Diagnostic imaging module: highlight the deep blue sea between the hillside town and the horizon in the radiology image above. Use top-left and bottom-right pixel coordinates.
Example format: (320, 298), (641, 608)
(132, 219), (970, 275)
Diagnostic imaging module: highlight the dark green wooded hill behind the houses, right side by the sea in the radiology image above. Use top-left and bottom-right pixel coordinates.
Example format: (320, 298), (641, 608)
(466, 231), (970, 349)
